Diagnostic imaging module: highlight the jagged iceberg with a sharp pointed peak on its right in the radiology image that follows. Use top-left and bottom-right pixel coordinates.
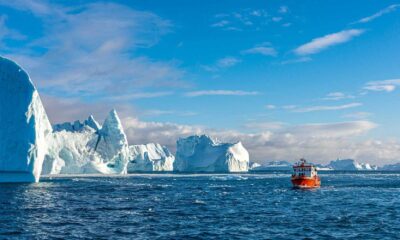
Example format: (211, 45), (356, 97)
(42, 110), (129, 175)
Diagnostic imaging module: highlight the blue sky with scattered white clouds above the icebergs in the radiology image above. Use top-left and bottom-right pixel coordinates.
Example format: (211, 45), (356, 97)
(0, 0), (400, 165)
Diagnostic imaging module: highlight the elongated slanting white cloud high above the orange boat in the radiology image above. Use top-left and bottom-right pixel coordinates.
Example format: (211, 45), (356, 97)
(294, 29), (364, 55)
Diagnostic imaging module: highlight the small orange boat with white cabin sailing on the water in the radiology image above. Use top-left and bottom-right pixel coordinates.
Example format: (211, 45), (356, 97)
(292, 158), (321, 188)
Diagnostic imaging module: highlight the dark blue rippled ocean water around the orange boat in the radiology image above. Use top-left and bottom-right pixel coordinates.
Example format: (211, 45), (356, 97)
(0, 173), (400, 239)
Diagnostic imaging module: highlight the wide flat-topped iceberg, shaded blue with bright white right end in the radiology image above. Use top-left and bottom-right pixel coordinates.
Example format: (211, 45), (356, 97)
(174, 135), (249, 172)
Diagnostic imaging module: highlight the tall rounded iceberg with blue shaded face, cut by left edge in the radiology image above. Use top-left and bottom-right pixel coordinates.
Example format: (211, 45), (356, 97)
(0, 57), (52, 182)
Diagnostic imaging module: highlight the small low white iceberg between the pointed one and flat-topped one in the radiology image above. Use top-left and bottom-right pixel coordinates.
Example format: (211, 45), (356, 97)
(128, 143), (175, 172)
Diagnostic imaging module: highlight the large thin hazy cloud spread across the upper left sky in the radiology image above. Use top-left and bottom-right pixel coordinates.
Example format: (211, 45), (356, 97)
(0, 1), (185, 98)
